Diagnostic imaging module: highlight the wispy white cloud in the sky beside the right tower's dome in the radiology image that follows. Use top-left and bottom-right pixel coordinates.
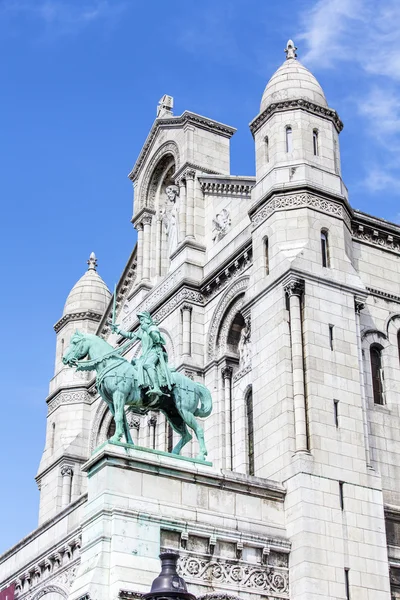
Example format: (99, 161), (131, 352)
(298, 0), (400, 192)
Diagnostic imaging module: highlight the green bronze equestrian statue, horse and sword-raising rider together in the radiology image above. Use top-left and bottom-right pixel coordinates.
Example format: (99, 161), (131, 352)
(63, 312), (212, 460)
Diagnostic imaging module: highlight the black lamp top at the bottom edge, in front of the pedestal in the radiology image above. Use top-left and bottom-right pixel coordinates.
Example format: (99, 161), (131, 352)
(143, 551), (197, 600)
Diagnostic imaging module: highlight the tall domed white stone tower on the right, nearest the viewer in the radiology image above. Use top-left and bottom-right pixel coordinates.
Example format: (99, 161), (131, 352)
(247, 40), (388, 600)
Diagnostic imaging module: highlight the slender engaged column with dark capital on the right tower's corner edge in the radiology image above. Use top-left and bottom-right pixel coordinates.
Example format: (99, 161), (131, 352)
(285, 278), (308, 452)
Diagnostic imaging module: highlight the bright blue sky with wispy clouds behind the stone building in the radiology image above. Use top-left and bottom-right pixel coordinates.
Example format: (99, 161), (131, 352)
(0, 0), (400, 552)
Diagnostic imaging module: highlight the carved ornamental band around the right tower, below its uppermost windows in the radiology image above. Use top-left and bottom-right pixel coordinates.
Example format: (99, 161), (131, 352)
(251, 192), (351, 229)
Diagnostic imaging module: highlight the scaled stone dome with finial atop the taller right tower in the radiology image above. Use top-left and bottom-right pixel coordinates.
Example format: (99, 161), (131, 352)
(260, 40), (328, 112)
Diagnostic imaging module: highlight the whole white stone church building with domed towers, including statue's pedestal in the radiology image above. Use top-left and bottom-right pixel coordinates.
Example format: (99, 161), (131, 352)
(0, 41), (400, 600)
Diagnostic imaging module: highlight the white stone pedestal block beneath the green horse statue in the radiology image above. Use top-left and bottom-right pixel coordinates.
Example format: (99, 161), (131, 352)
(70, 443), (289, 600)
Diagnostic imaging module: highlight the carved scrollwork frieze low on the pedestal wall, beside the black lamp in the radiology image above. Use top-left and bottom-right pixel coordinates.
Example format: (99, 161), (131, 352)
(178, 555), (289, 598)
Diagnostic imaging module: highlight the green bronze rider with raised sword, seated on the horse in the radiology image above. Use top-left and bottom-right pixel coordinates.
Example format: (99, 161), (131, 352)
(111, 311), (172, 397)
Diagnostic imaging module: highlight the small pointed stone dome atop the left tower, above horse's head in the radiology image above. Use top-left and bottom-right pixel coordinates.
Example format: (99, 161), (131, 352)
(63, 252), (111, 316)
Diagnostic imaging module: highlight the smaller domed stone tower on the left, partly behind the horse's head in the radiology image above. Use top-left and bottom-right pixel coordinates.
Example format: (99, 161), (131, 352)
(36, 252), (111, 523)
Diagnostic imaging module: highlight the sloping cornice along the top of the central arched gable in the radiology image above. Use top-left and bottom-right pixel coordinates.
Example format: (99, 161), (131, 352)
(128, 111), (236, 181)
